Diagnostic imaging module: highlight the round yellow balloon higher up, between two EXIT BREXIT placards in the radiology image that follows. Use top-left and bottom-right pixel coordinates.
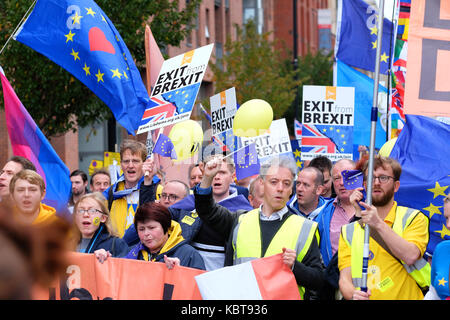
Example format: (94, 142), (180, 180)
(233, 99), (273, 137)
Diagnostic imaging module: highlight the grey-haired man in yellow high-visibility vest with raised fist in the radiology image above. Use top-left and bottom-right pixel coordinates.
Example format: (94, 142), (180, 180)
(194, 157), (324, 299)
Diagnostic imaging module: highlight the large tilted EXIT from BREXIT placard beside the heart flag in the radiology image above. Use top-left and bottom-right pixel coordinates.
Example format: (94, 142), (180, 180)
(137, 43), (214, 134)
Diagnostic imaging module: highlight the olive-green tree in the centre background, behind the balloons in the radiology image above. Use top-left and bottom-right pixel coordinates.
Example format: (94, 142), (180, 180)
(209, 21), (304, 119)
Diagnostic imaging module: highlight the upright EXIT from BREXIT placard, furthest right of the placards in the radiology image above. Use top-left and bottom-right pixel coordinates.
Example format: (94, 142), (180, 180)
(301, 86), (355, 161)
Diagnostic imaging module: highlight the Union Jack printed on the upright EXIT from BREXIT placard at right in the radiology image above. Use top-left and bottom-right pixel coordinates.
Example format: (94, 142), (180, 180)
(301, 124), (336, 153)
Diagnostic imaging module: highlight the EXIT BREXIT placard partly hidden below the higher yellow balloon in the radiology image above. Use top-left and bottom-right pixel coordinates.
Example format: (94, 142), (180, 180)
(241, 118), (292, 163)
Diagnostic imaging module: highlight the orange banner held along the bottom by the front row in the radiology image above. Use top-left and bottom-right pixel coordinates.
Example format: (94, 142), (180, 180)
(33, 253), (205, 300)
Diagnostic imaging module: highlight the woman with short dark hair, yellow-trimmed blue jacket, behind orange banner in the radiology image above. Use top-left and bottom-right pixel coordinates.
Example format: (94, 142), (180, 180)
(125, 202), (205, 270)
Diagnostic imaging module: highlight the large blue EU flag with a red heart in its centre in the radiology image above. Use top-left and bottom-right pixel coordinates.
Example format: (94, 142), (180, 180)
(15, 0), (150, 135)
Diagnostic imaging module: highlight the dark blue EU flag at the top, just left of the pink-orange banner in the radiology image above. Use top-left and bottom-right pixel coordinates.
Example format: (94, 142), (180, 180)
(336, 0), (394, 74)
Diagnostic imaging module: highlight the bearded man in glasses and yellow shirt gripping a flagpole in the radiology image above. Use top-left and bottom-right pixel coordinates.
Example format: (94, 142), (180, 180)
(338, 156), (430, 300)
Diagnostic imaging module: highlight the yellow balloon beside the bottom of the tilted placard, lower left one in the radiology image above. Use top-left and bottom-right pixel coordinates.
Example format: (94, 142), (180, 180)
(169, 120), (203, 162)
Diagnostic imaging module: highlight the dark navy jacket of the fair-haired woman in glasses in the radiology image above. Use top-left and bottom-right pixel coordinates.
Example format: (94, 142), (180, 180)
(77, 223), (130, 258)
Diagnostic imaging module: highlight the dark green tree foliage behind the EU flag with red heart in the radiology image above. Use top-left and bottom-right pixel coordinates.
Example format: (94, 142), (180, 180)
(0, 0), (201, 136)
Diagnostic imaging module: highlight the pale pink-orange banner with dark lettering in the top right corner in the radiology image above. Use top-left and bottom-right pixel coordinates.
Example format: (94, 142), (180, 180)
(404, 0), (450, 117)
